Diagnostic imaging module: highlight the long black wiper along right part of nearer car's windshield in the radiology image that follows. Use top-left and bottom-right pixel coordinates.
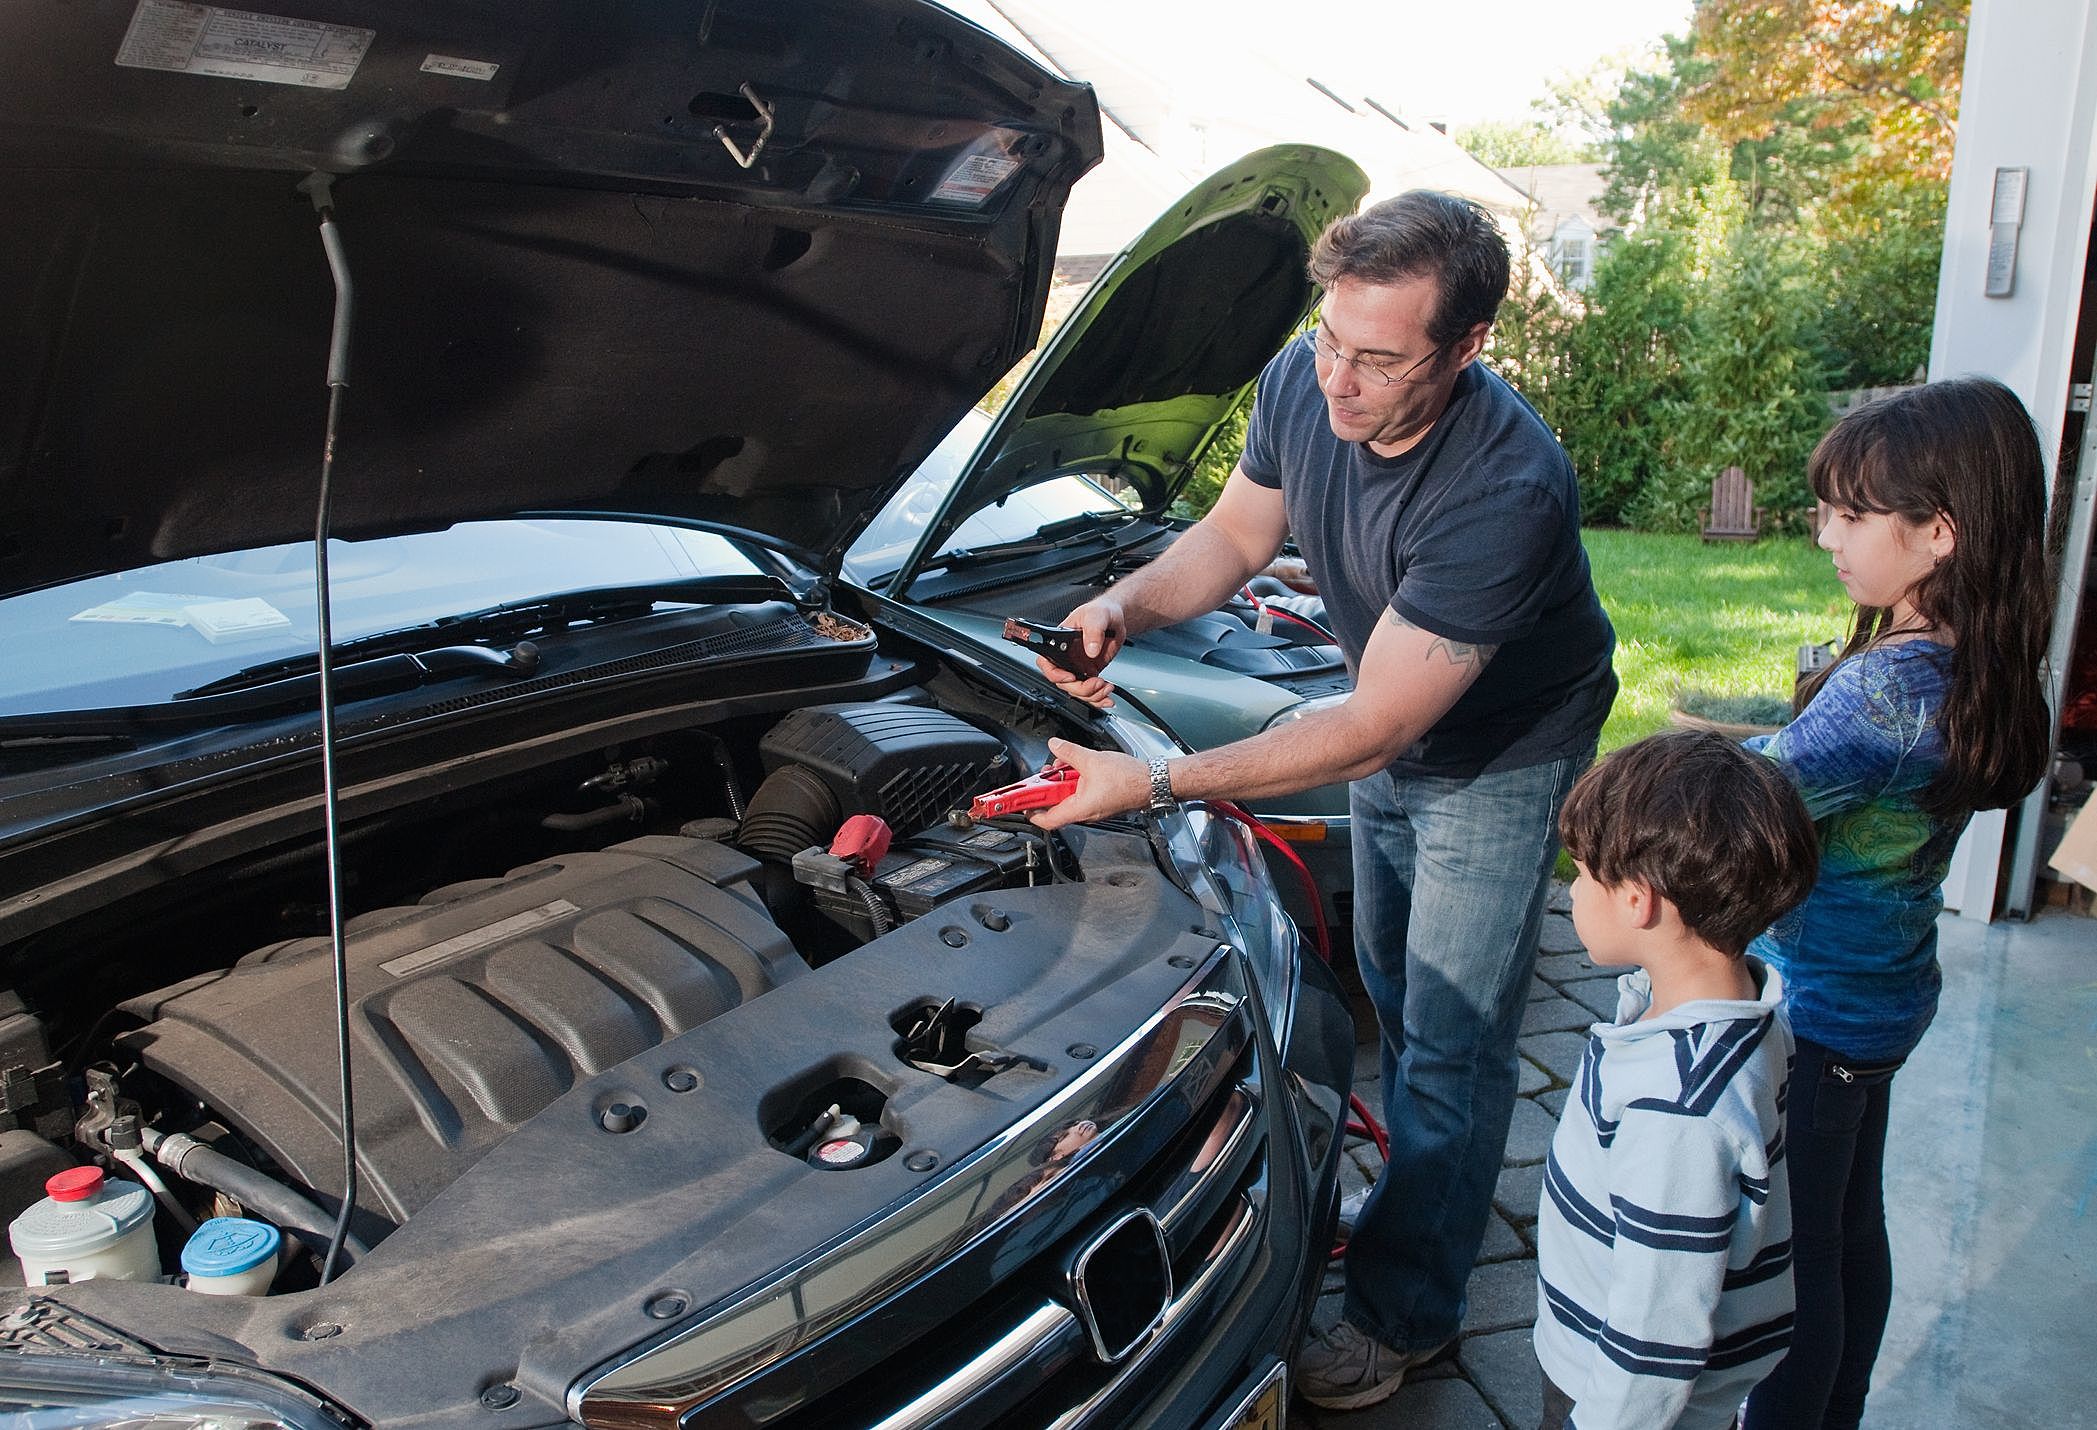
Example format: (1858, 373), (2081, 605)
(174, 577), (793, 700)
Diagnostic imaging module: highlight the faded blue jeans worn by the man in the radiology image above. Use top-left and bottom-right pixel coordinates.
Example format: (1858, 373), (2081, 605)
(1346, 753), (1592, 1352)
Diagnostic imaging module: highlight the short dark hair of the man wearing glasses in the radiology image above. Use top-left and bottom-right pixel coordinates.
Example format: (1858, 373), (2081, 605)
(1309, 189), (1508, 346)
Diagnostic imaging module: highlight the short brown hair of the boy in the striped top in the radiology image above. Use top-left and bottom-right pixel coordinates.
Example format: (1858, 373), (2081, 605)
(1558, 730), (1820, 958)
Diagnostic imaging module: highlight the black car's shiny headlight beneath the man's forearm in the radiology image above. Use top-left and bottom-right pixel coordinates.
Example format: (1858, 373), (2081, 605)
(1107, 715), (1302, 1053)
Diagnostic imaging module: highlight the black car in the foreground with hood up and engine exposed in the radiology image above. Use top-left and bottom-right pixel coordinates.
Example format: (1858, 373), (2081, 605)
(0, 0), (1353, 1430)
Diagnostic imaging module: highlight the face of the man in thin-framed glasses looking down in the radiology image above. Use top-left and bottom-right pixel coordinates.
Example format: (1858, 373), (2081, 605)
(1315, 277), (1487, 457)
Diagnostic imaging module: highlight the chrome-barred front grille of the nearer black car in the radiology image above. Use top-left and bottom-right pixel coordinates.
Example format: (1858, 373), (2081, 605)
(579, 939), (1271, 1430)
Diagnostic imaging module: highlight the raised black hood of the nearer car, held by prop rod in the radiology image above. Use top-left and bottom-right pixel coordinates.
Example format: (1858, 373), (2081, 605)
(0, 0), (1101, 593)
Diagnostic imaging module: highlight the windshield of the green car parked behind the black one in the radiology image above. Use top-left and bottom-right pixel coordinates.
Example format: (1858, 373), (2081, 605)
(845, 411), (1130, 585)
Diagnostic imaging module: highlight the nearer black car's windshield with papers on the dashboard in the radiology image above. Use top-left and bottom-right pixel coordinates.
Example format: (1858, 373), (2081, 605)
(0, 518), (757, 715)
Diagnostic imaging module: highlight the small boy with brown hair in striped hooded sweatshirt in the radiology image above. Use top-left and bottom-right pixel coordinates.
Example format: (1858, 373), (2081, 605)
(1535, 730), (1818, 1430)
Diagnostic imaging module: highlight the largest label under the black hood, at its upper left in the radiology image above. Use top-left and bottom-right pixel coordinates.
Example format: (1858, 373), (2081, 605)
(117, 0), (377, 90)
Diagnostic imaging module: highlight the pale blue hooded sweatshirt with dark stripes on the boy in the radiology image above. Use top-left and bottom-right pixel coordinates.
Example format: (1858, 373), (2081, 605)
(1535, 958), (1793, 1430)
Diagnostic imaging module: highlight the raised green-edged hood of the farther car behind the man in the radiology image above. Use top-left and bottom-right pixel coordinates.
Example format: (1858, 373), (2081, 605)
(893, 145), (1369, 593)
